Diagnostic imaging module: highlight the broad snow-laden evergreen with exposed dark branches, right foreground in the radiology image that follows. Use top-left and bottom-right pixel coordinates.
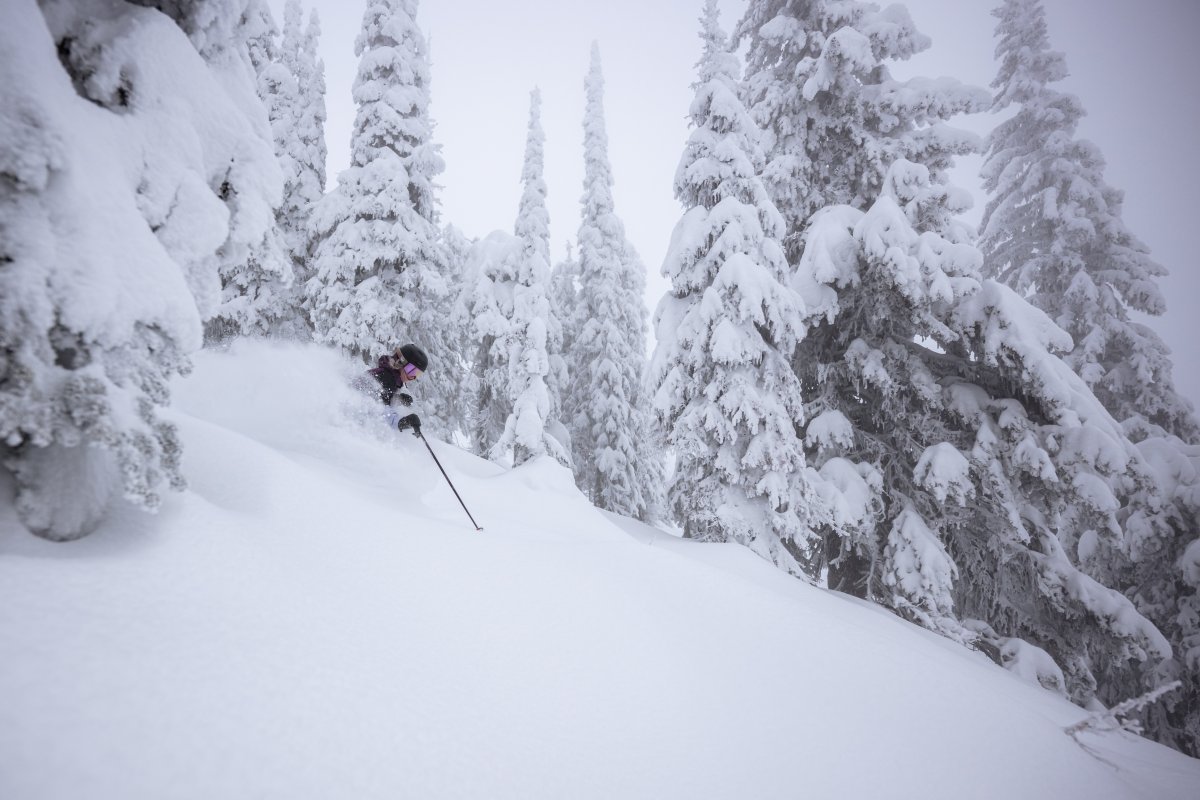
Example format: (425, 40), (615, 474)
(797, 161), (1169, 703)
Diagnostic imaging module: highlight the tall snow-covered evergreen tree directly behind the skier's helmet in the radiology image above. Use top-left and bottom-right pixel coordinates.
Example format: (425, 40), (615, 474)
(306, 0), (462, 431)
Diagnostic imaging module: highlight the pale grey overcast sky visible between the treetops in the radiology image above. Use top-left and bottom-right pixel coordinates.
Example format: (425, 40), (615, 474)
(278, 0), (1200, 404)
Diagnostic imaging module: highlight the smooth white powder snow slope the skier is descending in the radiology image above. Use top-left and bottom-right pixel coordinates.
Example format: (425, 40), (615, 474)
(0, 344), (1200, 800)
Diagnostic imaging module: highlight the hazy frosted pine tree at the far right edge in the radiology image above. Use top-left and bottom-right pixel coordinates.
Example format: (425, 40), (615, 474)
(980, 0), (1200, 754)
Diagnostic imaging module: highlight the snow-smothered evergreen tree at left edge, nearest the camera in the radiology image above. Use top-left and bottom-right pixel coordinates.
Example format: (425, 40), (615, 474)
(0, 0), (281, 540)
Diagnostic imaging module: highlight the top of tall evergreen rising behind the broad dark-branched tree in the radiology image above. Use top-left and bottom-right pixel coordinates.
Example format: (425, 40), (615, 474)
(734, 0), (989, 256)
